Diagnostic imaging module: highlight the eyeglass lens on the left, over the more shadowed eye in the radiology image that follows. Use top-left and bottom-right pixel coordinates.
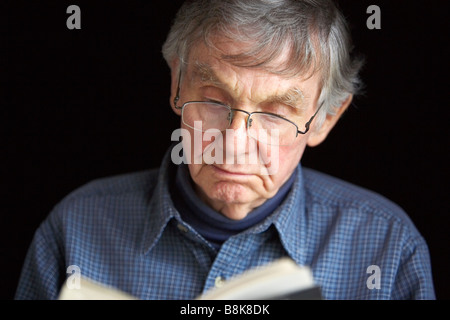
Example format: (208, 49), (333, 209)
(182, 102), (230, 132)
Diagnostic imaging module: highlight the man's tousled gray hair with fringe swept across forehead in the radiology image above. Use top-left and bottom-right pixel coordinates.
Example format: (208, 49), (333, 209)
(162, 0), (362, 130)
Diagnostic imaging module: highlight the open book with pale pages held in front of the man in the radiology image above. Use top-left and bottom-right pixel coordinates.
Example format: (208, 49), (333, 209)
(59, 258), (322, 300)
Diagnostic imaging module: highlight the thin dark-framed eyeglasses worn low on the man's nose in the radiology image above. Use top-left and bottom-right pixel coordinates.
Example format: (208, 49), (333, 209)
(174, 74), (323, 146)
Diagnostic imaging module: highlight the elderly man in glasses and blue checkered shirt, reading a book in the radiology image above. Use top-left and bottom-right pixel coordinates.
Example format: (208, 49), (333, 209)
(16, 0), (435, 299)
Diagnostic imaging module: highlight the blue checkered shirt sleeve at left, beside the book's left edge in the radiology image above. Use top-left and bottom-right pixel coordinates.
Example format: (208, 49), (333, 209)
(15, 210), (65, 300)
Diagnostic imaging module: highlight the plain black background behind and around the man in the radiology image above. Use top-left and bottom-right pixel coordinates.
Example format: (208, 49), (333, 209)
(4, 0), (450, 300)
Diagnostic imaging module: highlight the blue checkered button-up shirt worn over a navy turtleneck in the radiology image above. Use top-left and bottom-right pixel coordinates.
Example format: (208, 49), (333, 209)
(16, 148), (435, 300)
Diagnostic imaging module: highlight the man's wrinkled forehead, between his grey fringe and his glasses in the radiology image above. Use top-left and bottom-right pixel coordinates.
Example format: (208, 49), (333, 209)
(182, 39), (321, 108)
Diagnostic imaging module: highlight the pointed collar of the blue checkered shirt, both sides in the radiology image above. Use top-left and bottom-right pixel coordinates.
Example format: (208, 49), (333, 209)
(142, 146), (306, 265)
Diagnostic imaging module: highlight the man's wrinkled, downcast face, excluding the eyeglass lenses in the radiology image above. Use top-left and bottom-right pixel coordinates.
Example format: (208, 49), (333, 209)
(172, 35), (320, 220)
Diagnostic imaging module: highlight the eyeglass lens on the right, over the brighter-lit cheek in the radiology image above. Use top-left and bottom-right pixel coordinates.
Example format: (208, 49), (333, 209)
(248, 113), (297, 146)
